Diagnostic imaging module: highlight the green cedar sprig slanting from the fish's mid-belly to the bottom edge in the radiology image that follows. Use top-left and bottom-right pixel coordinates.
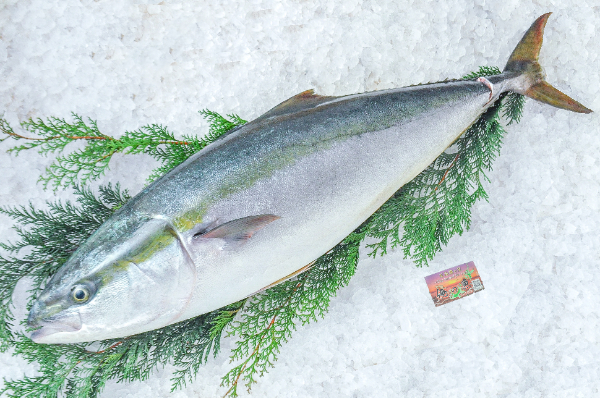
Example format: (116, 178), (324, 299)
(221, 229), (364, 397)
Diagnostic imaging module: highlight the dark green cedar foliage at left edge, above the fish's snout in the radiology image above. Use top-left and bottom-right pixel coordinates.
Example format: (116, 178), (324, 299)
(0, 185), (129, 351)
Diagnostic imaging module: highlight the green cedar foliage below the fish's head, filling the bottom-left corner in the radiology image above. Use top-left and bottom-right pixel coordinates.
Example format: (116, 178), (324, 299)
(0, 303), (243, 398)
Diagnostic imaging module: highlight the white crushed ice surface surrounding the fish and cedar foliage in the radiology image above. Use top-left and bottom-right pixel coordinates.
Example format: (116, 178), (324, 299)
(0, 0), (600, 398)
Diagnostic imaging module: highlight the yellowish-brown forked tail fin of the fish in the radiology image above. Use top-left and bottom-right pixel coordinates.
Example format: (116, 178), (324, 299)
(503, 12), (592, 113)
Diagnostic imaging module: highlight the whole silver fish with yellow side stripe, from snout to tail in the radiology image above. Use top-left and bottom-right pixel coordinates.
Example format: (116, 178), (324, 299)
(28, 13), (591, 343)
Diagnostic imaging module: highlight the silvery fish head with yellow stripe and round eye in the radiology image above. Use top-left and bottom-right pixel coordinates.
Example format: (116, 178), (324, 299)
(28, 219), (195, 344)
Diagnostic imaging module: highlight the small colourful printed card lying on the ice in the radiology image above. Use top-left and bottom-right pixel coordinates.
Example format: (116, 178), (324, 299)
(425, 261), (484, 307)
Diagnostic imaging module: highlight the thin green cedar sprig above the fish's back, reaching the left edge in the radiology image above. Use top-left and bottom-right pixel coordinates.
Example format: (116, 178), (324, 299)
(0, 110), (246, 190)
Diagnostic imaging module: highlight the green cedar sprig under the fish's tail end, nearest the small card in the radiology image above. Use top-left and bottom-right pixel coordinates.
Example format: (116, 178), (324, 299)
(367, 67), (524, 266)
